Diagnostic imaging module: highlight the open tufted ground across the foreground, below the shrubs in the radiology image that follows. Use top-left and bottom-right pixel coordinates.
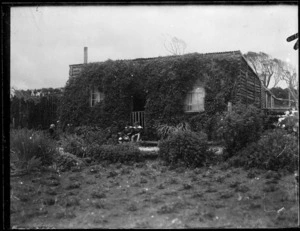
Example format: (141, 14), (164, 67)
(10, 160), (299, 228)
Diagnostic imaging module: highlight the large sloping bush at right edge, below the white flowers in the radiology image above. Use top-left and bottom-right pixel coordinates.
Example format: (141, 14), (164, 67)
(229, 129), (299, 172)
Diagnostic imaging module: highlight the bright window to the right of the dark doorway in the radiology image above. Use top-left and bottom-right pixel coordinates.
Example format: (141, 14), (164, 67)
(185, 87), (205, 112)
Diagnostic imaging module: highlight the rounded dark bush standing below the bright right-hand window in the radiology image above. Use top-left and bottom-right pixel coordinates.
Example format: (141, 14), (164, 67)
(159, 131), (210, 167)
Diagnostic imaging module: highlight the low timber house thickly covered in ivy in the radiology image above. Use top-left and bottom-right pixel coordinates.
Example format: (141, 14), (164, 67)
(61, 51), (264, 138)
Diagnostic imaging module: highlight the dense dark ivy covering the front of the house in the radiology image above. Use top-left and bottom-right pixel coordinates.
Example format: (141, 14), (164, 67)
(59, 53), (245, 138)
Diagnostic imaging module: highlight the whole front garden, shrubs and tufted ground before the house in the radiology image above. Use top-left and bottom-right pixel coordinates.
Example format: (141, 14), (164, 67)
(10, 105), (299, 228)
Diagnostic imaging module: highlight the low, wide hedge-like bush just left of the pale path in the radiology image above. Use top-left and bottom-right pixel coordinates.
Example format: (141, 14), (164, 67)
(87, 143), (142, 163)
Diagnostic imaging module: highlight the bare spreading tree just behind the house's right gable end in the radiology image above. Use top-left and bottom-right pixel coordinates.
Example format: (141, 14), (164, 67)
(244, 51), (280, 88)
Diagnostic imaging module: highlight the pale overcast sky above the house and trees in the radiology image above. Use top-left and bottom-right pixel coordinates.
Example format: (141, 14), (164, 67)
(10, 5), (299, 90)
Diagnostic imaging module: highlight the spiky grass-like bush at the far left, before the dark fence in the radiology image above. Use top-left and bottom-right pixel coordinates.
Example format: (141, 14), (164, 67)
(10, 128), (57, 166)
